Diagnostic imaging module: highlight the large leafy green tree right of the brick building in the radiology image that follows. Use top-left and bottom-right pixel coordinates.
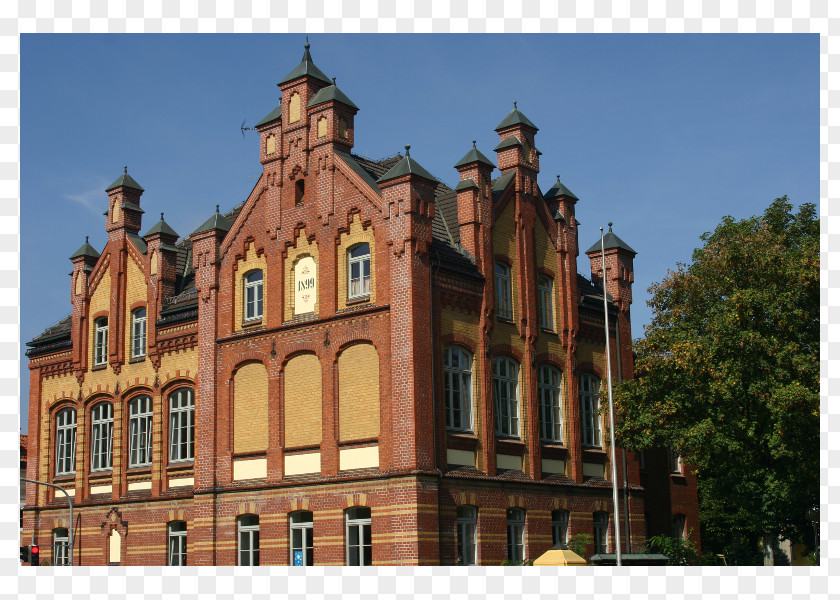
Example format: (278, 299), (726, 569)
(615, 197), (820, 561)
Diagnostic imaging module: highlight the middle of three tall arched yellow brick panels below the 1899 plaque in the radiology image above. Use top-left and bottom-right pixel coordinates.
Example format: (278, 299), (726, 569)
(283, 354), (321, 447)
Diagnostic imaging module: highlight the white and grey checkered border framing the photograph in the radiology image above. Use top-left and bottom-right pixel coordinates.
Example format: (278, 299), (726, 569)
(0, 0), (840, 600)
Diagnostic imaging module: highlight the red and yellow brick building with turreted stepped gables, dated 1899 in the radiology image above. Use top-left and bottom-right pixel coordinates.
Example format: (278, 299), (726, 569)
(24, 44), (699, 565)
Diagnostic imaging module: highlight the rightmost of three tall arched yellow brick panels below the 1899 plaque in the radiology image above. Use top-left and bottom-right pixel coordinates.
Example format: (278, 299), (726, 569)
(338, 344), (379, 441)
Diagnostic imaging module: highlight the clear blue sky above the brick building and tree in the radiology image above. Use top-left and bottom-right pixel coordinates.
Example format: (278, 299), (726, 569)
(20, 34), (820, 432)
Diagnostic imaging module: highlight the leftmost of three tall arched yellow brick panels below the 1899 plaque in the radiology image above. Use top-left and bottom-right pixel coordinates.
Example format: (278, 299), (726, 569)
(233, 363), (268, 452)
